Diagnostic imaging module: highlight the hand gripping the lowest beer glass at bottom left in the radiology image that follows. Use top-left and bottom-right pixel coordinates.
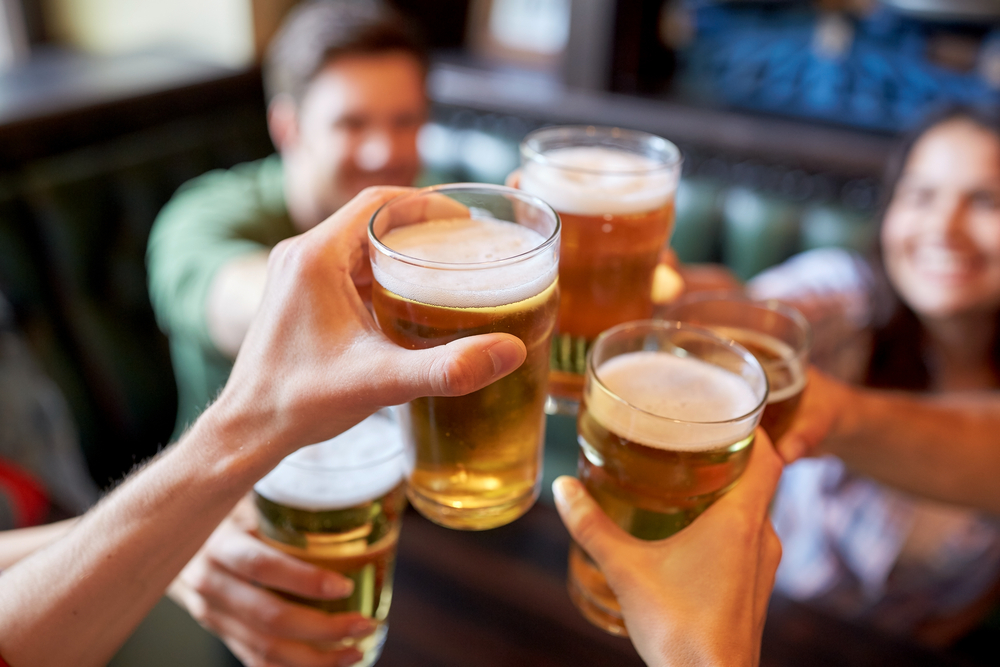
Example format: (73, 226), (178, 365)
(167, 496), (375, 667)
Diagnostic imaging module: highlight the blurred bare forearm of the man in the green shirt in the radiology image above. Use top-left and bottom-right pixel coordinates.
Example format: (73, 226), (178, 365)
(205, 251), (268, 359)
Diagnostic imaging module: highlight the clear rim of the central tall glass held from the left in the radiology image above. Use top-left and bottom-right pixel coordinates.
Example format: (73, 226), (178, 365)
(368, 183), (562, 271)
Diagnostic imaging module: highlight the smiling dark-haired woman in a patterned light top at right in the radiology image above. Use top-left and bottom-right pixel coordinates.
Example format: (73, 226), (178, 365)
(751, 108), (1000, 645)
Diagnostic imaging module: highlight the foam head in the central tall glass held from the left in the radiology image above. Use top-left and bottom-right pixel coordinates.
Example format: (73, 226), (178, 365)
(372, 218), (558, 308)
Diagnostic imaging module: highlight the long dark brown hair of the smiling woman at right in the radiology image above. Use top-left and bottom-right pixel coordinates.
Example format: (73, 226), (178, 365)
(865, 105), (1000, 390)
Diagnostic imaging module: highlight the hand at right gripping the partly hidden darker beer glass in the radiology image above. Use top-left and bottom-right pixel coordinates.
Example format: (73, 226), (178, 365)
(777, 367), (856, 463)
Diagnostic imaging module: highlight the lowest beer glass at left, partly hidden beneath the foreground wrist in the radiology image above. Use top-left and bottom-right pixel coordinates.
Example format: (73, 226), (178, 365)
(254, 413), (406, 666)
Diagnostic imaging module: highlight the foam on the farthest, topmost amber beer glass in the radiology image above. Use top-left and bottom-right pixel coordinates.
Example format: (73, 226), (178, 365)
(518, 146), (678, 215)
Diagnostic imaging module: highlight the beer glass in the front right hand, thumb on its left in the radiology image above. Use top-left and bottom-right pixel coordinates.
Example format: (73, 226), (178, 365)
(568, 320), (767, 636)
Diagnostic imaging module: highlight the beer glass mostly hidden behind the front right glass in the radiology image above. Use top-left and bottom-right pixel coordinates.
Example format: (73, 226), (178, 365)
(665, 292), (812, 442)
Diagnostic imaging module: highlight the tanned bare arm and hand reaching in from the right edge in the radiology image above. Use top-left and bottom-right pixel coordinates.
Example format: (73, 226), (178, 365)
(779, 370), (1000, 513)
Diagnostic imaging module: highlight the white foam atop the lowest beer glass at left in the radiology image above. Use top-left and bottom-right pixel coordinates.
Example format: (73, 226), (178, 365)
(254, 414), (404, 512)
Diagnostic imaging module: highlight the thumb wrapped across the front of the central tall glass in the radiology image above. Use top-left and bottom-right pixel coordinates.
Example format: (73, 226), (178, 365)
(399, 333), (528, 400)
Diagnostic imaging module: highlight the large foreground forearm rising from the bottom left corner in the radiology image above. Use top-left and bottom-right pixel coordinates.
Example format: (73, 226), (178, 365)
(0, 414), (286, 667)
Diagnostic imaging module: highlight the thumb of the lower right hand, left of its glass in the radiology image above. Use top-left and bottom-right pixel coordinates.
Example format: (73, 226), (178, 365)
(552, 475), (633, 569)
